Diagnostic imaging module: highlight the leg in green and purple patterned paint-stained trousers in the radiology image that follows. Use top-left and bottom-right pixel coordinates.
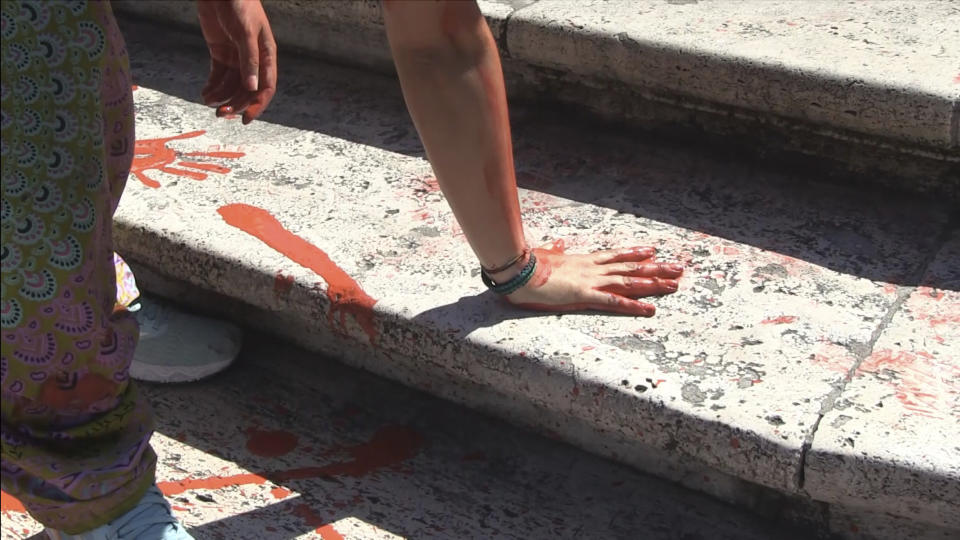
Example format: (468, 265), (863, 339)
(0, 1), (186, 533)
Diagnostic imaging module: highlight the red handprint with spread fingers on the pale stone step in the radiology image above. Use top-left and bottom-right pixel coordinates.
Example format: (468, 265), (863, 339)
(130, 130), (244, 188)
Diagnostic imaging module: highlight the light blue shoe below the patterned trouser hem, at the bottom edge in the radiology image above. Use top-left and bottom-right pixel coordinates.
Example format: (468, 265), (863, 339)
(49, 486), (194, 540)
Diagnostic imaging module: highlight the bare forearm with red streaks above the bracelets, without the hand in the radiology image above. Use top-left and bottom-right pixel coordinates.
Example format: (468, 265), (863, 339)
(385, 0), (525, 268)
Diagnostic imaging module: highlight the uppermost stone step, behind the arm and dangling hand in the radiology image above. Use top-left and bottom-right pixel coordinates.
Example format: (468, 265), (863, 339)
(115, 0), (960, 201)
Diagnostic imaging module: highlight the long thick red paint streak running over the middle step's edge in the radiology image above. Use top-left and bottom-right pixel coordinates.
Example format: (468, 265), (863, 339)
(217, 204), (378, 344)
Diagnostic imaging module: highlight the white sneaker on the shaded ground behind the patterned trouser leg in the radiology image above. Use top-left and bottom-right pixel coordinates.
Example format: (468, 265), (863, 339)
(129, 296), (243, 383)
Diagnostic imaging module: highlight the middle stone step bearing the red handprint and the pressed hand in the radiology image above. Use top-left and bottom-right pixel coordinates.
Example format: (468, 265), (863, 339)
(115, 16), (960, 538)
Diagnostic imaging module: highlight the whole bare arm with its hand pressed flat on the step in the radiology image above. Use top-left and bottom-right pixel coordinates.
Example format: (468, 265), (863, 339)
(383, 0), (683, 316)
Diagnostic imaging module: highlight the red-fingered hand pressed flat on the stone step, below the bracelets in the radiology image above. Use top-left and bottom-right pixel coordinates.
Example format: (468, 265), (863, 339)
(507, 240), (683, 317)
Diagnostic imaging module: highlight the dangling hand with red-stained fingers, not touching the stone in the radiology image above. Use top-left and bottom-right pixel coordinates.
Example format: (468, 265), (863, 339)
(197, 0), (277, 124)
